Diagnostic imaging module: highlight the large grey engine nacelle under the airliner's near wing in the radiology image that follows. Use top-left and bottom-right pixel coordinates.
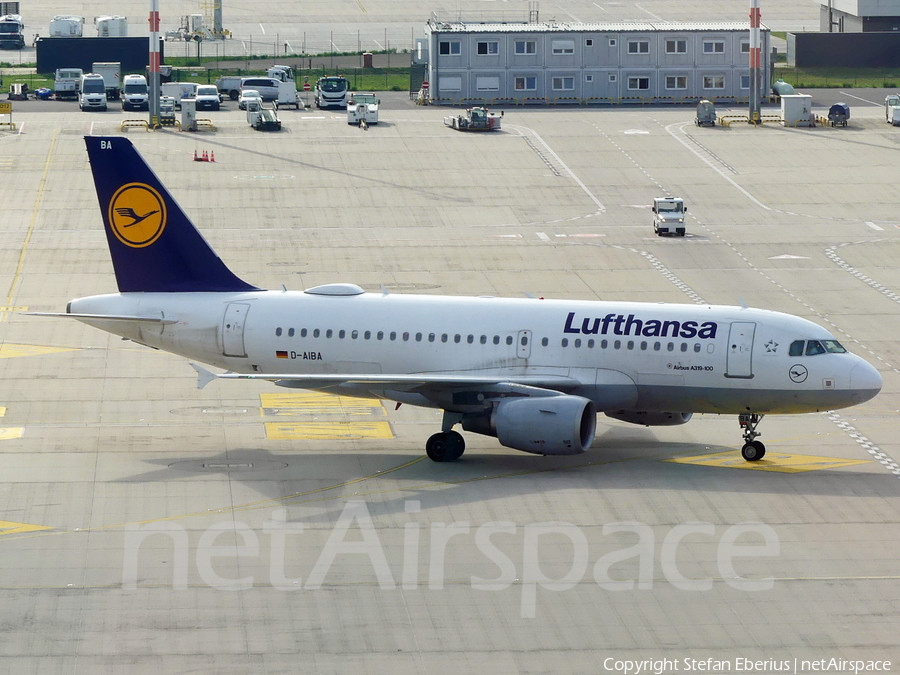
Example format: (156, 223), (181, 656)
(462, 396), (597, 455)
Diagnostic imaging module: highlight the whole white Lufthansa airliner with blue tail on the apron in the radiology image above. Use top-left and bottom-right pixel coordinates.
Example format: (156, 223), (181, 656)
(33, 137), (882, 462)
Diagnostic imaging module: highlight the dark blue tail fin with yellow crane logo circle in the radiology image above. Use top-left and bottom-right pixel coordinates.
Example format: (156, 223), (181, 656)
(84, 136), (258, 293)
